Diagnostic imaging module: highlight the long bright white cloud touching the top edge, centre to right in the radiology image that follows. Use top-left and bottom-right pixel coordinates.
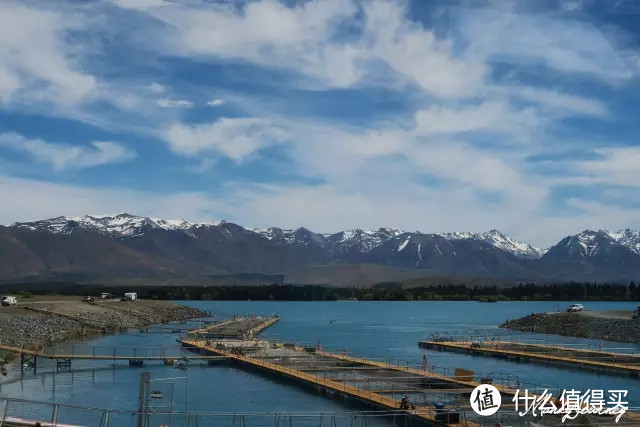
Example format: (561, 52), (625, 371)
(122, 0), (485, 98)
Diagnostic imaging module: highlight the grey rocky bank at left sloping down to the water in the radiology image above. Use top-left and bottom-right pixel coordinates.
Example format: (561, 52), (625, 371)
(0, 298), (207, 365)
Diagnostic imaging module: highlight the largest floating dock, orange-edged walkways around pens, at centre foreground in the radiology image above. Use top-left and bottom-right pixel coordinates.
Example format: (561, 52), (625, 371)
(180, 339), (488, 427)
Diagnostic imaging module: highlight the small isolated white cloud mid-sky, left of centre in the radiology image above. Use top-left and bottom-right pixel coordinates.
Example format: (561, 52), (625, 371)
(165, 118), (286, 161)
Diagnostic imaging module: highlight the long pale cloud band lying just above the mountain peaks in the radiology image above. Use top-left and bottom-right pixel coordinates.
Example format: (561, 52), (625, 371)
(0, 167), (640, 247)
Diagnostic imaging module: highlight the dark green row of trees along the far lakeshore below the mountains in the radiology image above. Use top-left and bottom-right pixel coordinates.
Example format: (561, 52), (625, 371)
(7, 282), (640, 301)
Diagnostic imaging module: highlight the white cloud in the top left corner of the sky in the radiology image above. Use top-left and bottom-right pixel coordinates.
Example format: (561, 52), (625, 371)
(0, 2), (98, 105)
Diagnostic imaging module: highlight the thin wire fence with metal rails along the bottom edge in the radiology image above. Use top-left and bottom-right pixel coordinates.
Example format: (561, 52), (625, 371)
(0, 397), (638, 427)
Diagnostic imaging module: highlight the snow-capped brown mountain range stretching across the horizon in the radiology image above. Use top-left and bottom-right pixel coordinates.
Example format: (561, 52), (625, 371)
(0, 213), (640, 284)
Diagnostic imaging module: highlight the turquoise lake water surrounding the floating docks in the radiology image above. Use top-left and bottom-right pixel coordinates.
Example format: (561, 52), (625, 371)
(0, 301), (640, 425)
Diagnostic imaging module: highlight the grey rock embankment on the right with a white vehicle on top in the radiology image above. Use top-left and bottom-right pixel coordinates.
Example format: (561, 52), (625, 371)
(500, 313), (640, 343)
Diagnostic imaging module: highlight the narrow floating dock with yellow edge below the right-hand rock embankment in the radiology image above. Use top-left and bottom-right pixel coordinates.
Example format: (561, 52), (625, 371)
(419, 341), (640, 376)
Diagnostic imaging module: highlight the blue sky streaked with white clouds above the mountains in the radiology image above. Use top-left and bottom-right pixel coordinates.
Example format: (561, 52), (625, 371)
(0, 0), (640, 247)
